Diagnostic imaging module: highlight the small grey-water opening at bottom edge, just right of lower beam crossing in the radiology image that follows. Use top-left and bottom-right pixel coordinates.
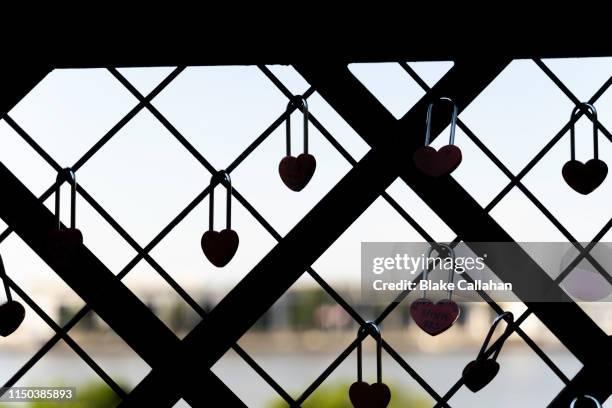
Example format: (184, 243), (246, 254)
(211, 350), (277, 407)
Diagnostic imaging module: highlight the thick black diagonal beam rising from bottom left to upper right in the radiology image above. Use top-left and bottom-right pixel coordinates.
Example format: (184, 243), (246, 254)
(117, 59), (506, 406)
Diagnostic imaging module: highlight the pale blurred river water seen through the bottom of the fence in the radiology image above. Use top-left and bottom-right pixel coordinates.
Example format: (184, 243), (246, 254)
(0, 348), (612, 408)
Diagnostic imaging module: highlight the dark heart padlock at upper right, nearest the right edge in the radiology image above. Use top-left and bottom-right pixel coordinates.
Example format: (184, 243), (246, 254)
(561, 103), (608, 195)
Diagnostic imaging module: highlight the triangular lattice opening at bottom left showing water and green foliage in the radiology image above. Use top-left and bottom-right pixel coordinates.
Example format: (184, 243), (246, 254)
(9, 340), (119, 407)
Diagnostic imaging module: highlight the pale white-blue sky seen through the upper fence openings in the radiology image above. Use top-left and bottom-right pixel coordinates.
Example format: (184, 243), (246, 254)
(0, 58), (612, 310)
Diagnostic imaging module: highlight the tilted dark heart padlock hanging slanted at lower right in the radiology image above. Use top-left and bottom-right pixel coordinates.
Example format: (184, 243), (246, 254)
(462, 312), (514, 392)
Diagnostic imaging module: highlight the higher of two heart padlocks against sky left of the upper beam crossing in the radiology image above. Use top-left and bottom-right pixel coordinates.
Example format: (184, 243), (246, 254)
(278, 95), (317, 191)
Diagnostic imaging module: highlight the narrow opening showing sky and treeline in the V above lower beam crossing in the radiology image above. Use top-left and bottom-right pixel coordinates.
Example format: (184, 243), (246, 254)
(122, 261), (201, 338)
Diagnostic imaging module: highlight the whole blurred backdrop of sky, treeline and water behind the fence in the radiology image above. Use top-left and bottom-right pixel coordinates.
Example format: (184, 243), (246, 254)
(0, 58), (612, 408)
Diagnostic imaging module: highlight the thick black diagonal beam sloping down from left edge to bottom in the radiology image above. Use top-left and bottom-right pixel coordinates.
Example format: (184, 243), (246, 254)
(0, 164), (244, 406)
